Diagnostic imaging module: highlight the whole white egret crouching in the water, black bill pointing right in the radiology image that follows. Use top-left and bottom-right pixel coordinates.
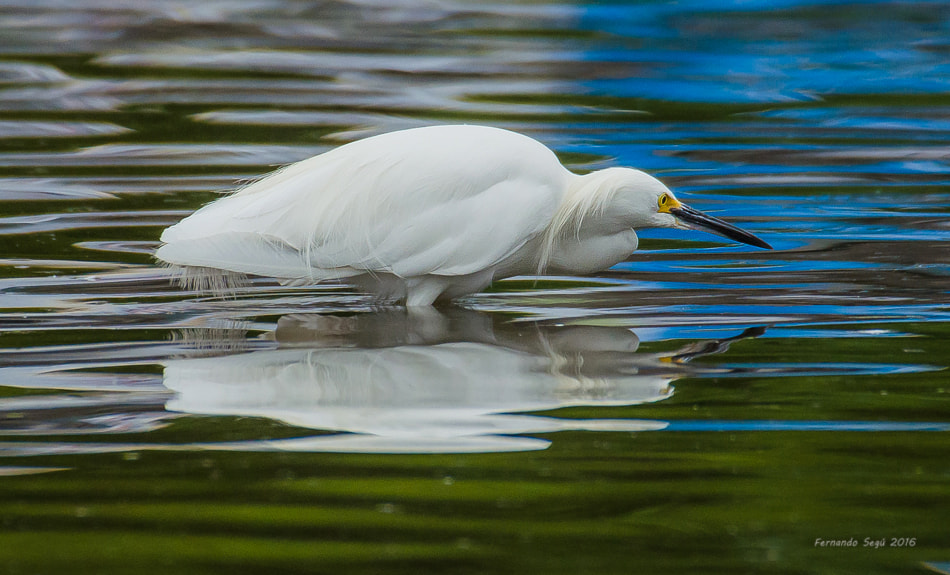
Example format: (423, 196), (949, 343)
(156, 126), (771, 306)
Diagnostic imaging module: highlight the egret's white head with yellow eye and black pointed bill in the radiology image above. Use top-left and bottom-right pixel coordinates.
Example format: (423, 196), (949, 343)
(604, 168), (772, 249)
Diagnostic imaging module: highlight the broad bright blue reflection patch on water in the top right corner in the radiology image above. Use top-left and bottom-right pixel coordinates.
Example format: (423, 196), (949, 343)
(581, 1), (950, 103)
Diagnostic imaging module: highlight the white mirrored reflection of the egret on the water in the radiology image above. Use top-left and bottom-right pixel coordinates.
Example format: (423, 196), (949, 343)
(164, 308), (762, 453)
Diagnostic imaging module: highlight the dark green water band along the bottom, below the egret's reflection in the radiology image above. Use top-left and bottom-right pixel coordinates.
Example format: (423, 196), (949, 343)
(0, 432), (950, 573)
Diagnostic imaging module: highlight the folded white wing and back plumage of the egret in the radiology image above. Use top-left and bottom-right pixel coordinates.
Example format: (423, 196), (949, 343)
(158, 126), (570, 280)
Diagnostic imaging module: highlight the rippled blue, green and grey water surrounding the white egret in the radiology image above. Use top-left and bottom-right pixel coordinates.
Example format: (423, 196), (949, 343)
(0, 0), (950, 573)
